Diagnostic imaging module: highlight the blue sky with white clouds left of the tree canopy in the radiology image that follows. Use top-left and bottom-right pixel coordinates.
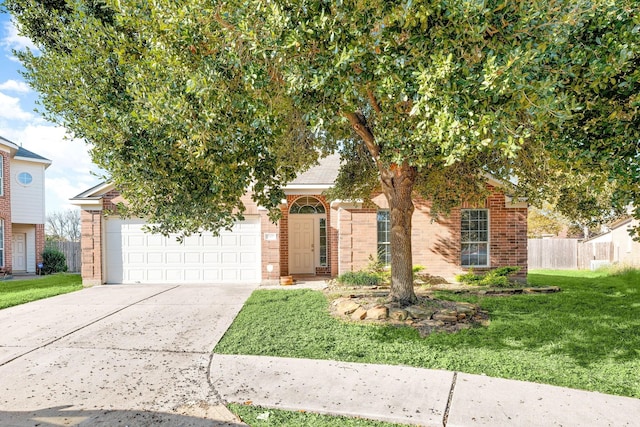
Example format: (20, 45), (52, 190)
(0, 13), (100, 214)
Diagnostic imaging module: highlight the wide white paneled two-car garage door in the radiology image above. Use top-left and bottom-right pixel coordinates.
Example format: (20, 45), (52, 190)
(106, 218), (260, 283)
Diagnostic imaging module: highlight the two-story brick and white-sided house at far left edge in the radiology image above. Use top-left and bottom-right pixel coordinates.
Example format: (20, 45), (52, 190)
(0, 136), (51, 273)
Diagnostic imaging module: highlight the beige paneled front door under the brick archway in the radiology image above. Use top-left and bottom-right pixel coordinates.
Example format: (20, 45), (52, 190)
(289, 215), (316, 274)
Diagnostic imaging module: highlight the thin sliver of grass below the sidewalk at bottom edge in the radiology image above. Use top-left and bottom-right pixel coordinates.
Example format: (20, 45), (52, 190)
(227, 404), (401, 427)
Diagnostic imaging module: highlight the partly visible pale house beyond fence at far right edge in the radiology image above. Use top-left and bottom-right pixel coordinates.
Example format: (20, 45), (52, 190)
(582, 216), (640, 267)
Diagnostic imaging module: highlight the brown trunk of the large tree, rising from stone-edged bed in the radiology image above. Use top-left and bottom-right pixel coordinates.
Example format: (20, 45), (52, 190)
(380, 164), (417, 305)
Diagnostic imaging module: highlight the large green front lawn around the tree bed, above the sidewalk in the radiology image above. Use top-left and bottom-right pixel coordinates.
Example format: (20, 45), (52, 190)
(215, 271), (640, 397)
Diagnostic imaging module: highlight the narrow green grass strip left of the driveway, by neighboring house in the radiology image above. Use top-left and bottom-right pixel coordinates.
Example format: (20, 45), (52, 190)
(0, 274), (82, 309)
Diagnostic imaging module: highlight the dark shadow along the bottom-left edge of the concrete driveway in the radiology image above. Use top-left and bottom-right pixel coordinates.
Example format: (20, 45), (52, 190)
(0, 405), (246, 427)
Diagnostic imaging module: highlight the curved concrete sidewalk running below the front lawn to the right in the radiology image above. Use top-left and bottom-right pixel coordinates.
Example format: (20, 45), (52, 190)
(210, 354), (640, 427)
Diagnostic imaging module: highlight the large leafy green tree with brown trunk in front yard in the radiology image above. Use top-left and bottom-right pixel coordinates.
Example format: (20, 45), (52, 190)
(5, 0), (640, 302)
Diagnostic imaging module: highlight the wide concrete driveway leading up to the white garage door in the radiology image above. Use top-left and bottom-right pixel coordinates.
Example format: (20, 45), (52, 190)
(0, 285), (256, 426)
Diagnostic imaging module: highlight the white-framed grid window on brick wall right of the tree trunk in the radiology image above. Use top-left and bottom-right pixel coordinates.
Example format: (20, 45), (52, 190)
(460, 209), (489, 267)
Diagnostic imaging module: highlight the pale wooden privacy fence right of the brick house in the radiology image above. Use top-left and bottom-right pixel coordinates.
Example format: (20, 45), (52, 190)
(528, 239), (613, 270)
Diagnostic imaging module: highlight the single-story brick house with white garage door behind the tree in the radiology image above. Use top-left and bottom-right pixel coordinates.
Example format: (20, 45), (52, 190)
(72, 155), (527, 285)
